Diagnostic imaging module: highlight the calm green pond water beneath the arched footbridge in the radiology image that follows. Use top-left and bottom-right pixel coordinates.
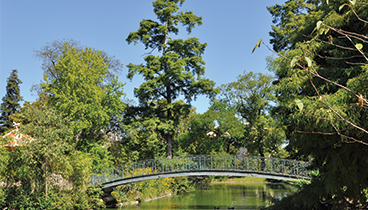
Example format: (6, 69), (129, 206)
(116, 181), (295, 210)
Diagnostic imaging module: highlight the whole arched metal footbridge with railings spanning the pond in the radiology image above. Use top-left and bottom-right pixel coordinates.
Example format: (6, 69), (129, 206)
(91, 155), (311, 188)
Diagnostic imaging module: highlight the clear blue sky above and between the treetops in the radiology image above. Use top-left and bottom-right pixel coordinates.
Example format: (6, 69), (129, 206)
(0, 0), (285, 113)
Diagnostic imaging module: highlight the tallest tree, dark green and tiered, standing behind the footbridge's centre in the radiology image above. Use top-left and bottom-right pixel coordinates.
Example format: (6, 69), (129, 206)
(126, 0), (216, 157)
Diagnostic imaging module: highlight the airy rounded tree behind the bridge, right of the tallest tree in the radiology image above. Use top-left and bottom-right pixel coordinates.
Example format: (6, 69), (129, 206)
(219, 72), (285, 156)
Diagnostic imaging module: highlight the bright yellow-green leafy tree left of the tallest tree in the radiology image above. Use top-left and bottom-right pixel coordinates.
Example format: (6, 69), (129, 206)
(41, 43), (124, 151)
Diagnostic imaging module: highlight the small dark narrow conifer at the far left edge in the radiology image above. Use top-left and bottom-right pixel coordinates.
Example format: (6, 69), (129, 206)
(0, 69), (23, 133)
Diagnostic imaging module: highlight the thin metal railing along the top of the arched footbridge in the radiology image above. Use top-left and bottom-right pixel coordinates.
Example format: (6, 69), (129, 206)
(91, 155), (310, 185)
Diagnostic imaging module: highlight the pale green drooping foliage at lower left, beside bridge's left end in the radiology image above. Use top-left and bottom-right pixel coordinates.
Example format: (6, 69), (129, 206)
(0, 101), (105, 209)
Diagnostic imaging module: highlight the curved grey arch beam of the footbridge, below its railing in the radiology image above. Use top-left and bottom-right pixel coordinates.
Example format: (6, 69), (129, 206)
(102, 170), (306, 188)
